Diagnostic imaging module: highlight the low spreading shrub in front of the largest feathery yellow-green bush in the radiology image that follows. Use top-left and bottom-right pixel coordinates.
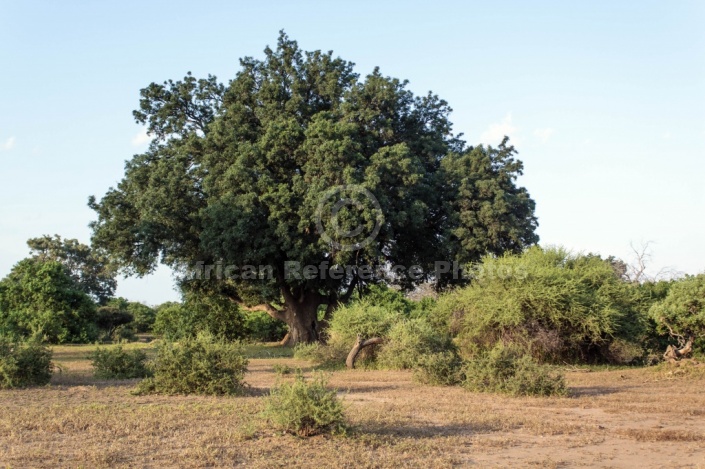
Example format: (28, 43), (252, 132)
(463, 346), (568, 396)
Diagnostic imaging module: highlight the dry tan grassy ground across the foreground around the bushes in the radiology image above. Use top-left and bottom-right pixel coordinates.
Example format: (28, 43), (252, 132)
(0, 344), (705, 468)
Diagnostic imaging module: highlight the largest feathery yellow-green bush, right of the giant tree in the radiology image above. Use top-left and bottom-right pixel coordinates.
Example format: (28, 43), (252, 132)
(434, 248), (649, 362)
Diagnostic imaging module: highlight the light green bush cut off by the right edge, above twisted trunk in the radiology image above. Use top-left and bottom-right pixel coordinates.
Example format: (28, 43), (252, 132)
(649, 274), (705, 351)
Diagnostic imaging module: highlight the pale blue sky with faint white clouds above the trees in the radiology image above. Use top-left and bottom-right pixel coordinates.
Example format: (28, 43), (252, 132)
(0, 0), (705, 304)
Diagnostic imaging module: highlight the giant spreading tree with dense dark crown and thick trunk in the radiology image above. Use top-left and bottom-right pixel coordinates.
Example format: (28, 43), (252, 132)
(89, 33), (538, 343)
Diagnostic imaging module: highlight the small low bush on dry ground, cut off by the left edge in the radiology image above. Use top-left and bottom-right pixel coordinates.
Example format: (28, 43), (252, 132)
(0, 337), (54, 389)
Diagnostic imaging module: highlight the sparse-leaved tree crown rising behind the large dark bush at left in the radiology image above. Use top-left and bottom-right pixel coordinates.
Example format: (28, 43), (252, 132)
(27, 235), (117, 304)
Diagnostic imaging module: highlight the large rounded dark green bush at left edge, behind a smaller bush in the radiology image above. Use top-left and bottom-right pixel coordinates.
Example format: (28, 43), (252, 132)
(0, 258), (98, 343)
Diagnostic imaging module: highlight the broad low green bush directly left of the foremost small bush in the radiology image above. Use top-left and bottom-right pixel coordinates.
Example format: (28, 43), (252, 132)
(135, 333), (248, 395)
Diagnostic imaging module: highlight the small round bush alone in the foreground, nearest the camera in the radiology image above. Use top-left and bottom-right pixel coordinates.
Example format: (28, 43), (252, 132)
(265, 371), (345, 436)
